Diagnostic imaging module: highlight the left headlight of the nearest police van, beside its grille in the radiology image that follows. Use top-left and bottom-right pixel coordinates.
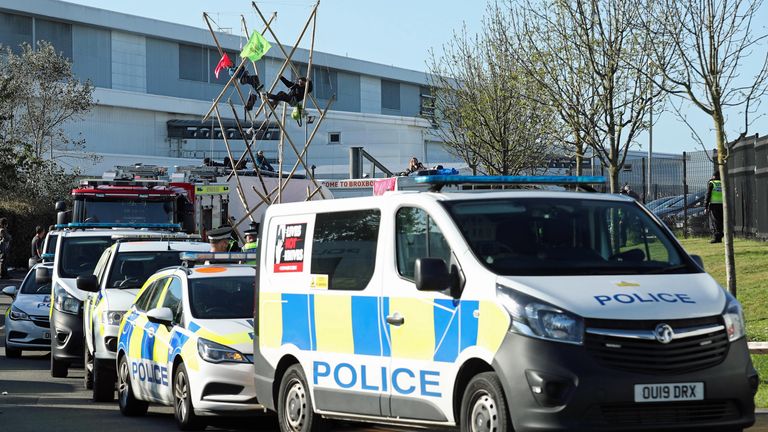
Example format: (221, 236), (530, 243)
(496, 285), (584, 344)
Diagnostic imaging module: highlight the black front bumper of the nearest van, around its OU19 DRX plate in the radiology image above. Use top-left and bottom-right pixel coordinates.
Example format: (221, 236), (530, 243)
(493, 333), (757, 432)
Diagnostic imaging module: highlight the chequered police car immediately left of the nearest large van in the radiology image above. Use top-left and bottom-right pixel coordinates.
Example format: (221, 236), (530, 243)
(117, 253), (262, 429)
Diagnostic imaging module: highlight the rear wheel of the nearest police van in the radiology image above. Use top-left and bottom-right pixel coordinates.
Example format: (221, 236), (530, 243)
(277, 364), (324, 432)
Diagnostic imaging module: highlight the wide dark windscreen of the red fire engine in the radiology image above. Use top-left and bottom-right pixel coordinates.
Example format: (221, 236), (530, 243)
(75, 198), (175, 223)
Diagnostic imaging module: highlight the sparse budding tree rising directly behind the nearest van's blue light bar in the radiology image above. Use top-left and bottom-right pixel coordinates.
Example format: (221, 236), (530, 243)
(428, 8), (554, 175)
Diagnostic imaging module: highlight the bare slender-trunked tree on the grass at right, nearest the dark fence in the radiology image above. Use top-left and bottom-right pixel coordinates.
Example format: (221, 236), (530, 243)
(645, 0), (768, 295)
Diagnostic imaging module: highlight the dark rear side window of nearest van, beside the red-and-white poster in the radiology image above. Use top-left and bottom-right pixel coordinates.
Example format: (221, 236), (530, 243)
(311, 209), (381, 291)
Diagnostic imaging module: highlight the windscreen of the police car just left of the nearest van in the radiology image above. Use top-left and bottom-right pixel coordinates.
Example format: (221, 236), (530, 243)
(189, 276), (255, 319)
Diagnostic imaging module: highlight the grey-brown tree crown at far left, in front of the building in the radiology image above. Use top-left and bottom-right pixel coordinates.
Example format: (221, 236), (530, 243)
(0, 41), (94, 159)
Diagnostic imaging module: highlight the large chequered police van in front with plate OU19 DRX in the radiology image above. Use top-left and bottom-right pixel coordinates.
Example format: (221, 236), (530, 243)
(254, 176), (759, 432)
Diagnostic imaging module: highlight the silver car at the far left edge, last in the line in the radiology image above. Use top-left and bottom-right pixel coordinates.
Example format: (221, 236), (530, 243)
(3, 263), (53, 358)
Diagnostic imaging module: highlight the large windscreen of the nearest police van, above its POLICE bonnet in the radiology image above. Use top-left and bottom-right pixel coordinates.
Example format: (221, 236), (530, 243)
(443, 198), (700, 276)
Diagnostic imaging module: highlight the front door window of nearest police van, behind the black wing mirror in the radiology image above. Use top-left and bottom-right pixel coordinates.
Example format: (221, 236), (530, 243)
(395, 207), (451, 280)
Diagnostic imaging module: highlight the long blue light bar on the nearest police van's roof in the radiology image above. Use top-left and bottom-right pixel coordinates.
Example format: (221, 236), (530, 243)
(413, 175), (606, 192)
